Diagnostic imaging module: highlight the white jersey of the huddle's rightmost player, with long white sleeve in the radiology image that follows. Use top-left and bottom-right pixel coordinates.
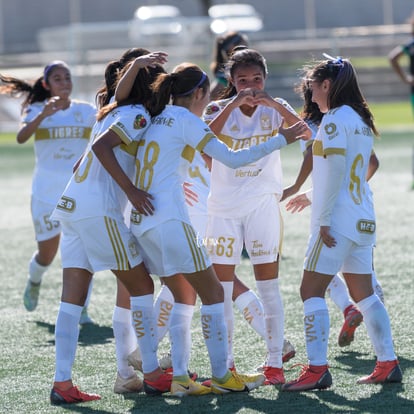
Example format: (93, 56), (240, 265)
(311, 105), (375, 245)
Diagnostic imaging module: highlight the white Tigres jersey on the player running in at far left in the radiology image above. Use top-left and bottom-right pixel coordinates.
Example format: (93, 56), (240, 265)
(22, 100), (96, 204)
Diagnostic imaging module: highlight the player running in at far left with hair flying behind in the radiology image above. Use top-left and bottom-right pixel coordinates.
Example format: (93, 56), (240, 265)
(0, 60), (96, 323)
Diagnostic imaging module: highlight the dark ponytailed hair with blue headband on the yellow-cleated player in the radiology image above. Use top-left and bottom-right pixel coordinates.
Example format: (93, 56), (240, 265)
(150, 63), (210, 116)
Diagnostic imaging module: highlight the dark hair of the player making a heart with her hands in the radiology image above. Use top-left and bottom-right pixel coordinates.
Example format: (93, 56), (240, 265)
(219, 46), (267, 99)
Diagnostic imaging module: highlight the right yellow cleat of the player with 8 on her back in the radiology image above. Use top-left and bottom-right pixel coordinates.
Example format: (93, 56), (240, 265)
(211, 371), (265, 394)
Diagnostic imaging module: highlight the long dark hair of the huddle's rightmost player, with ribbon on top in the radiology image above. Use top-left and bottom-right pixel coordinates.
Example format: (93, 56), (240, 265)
(309, 57), (379, 136)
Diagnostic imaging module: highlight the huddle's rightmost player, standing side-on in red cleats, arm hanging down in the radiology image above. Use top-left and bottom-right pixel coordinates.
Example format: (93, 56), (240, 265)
(282, 57), (402, 391)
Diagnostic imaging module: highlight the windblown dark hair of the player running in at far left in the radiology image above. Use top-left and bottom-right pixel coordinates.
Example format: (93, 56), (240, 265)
(0, 60), (70, 108)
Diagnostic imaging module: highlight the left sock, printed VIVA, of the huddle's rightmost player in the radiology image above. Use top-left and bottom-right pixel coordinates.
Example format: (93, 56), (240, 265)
(303, 297), (329, 365)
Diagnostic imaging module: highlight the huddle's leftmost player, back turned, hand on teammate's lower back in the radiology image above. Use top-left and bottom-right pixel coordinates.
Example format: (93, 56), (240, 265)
(50, 56), (171, 404)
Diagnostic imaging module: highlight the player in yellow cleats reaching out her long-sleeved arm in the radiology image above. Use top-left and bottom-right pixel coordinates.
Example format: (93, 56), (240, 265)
(124, 64), (308, 395)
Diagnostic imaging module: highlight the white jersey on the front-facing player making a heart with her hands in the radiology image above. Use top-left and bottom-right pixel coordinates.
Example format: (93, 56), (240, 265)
(204, 98), (294, 217)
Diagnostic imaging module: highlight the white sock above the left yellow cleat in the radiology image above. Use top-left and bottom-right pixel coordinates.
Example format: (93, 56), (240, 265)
(170, 303), (194, 377)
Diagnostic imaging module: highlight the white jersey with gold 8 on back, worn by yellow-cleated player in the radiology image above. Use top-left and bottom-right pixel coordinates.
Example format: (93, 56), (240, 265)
(131, 105), (214, 237)
